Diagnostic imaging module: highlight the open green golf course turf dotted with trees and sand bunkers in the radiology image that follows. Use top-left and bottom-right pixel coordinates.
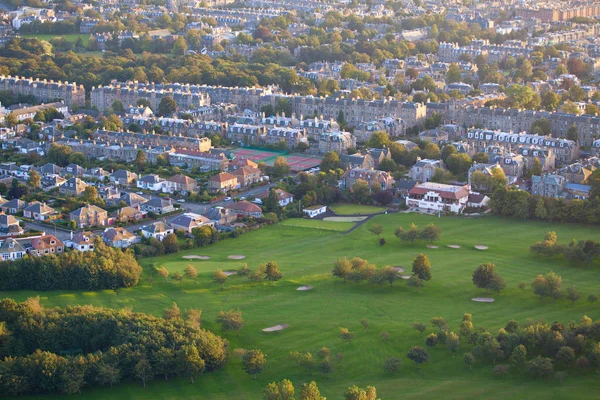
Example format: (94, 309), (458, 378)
(7, 214), (600, 400)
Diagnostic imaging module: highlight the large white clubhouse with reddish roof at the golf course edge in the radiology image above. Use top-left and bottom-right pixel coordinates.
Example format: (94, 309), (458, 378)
(406, 182), (469, 213)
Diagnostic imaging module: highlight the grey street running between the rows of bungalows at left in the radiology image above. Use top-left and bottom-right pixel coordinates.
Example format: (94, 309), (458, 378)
(26, 184), (273, 242)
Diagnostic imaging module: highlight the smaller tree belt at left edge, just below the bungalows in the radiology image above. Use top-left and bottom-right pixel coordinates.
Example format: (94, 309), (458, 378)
(0, 238), (142, 290)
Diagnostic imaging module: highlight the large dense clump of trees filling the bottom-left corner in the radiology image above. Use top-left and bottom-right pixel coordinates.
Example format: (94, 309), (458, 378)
(0, 298), (228, 396)
